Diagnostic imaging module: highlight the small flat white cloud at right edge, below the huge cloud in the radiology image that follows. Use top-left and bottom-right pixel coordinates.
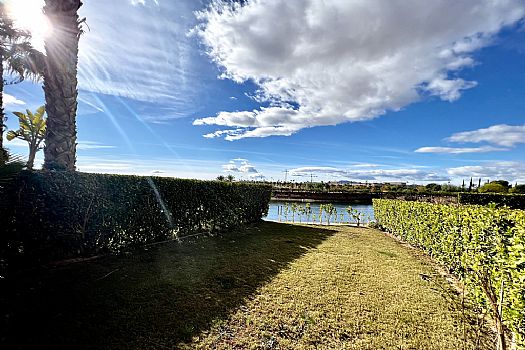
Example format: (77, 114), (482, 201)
(448, 124), (525, 147)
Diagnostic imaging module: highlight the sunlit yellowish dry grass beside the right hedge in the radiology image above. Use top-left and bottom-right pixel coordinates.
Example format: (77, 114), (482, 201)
(186, 227), (491, 349)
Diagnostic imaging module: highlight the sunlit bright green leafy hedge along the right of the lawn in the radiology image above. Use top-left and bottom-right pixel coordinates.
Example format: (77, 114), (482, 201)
(374, 199), (525, 349)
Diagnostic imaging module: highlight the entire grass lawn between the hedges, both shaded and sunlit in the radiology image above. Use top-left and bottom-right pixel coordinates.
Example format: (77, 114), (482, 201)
(0, 223), (490, 349)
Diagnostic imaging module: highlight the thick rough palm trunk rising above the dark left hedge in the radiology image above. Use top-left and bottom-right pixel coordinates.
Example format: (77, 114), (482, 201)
(44, 0), (83, 170)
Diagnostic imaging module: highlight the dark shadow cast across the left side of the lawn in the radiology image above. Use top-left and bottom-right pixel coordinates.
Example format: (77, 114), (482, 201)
(0, 222), (334, 349)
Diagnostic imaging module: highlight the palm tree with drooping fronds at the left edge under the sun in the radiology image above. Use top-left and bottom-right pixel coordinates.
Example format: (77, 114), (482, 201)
(0, 3), (44, 163)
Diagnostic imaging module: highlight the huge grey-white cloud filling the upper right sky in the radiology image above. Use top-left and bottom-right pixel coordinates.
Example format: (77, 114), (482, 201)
(194, 0), (525, 140)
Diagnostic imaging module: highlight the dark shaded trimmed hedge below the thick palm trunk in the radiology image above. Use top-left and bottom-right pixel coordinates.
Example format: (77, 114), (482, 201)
(0, 172), (271, 268)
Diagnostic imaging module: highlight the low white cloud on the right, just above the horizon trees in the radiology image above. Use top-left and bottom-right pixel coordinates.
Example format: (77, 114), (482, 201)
(447, 161), (525, 182)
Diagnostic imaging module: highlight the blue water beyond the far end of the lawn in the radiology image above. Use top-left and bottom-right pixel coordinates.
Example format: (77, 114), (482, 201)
(265, 201), (374, 223)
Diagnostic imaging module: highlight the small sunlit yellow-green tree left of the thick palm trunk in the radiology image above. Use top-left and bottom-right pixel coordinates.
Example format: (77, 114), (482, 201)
(7, 106), (46, 170)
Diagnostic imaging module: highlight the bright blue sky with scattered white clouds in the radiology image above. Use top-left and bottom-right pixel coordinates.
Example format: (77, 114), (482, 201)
(4, 0), (525, 184)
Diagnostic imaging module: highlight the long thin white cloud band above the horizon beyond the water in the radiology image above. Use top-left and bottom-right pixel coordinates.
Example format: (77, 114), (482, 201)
(290, 167), (449, 181)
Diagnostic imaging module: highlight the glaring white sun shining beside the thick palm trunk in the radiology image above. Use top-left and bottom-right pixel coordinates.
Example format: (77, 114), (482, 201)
(5, 0), (52, 51)
